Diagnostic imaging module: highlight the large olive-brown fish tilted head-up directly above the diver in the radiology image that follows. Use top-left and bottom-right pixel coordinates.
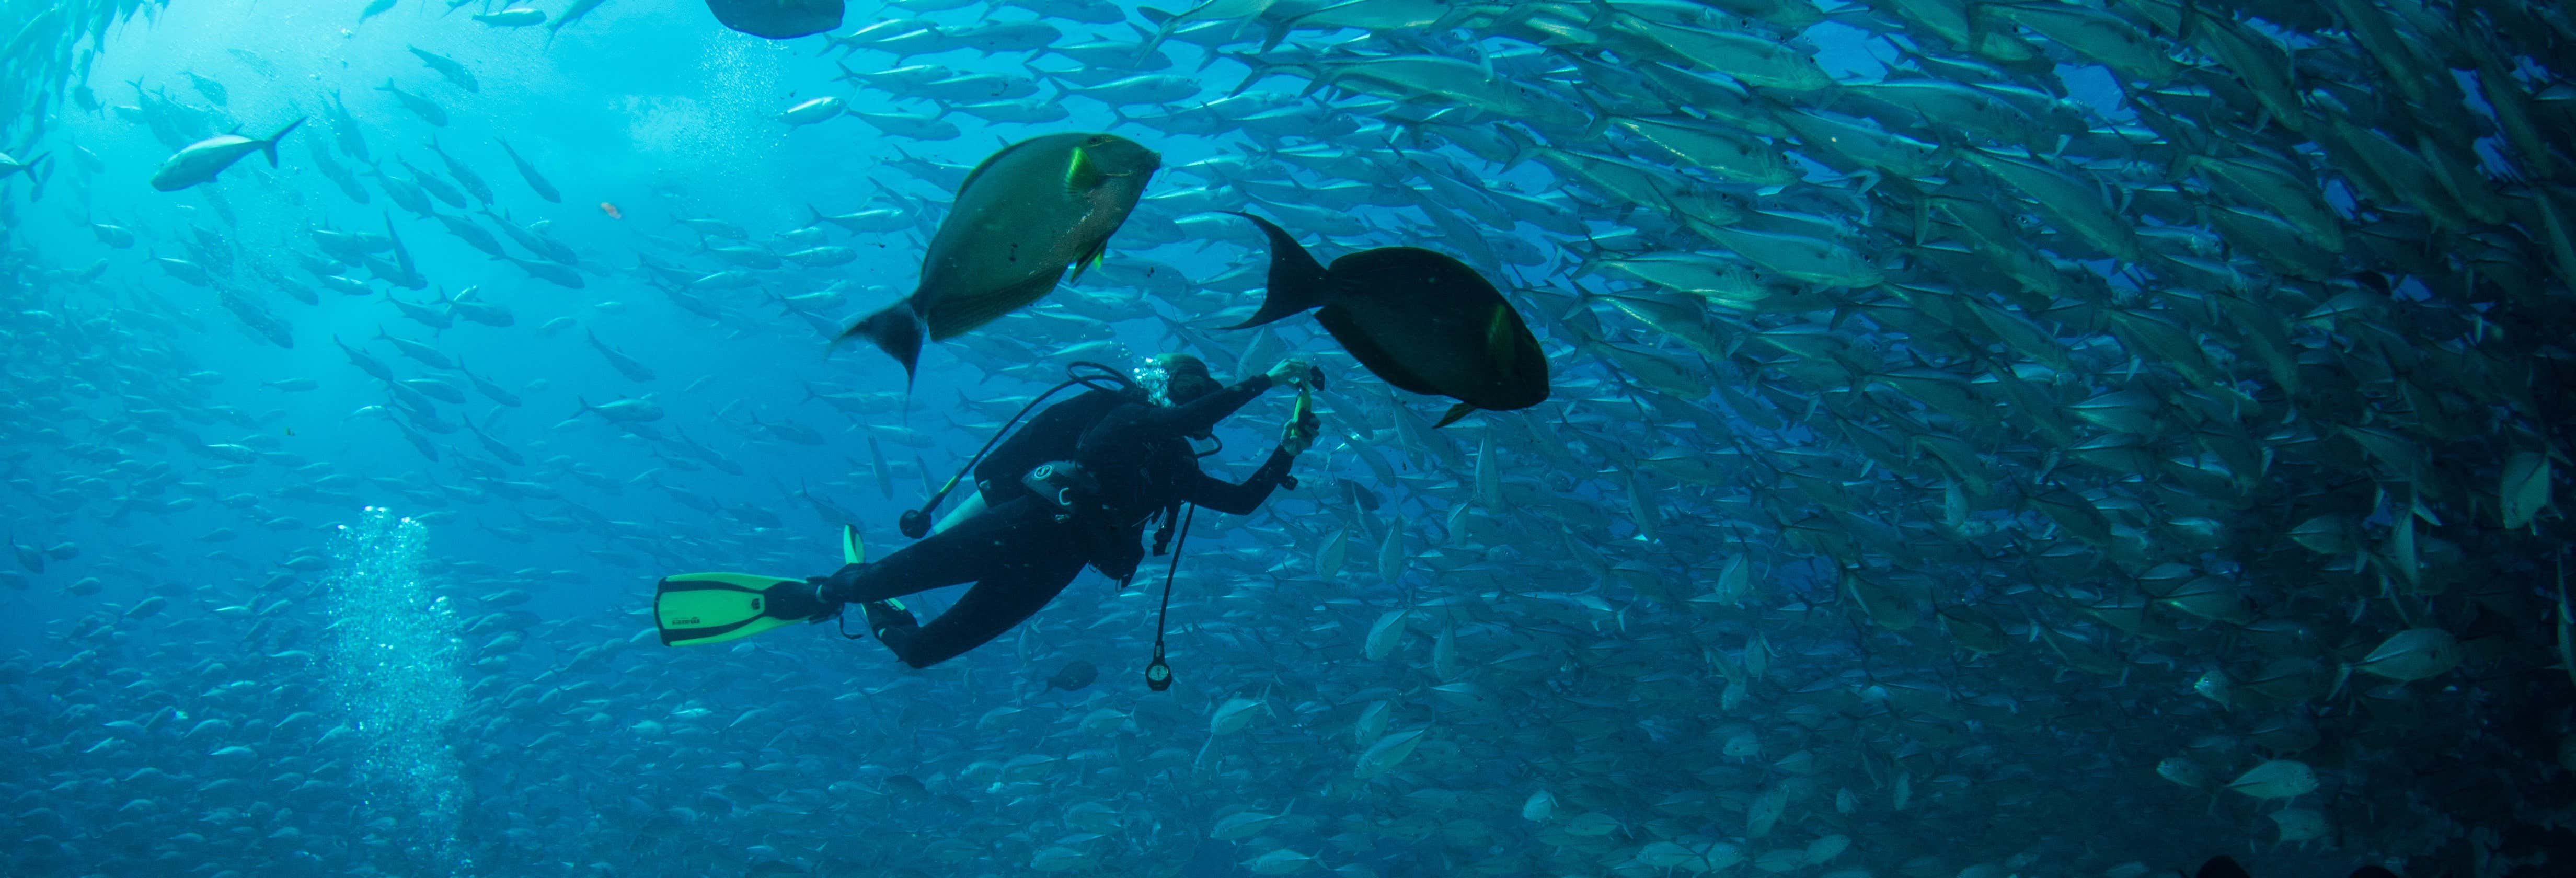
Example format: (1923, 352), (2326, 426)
(840, 131), (1162, 381)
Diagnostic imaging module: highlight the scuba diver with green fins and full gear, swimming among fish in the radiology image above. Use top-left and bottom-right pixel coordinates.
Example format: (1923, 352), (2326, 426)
(654, 353), (1321, 674)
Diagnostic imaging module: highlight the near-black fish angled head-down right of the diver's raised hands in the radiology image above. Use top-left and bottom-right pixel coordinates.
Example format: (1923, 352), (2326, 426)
(1226, 211), (1548, 428)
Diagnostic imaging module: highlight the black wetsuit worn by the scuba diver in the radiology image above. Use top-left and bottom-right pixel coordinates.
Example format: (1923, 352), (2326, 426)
(827, 376), (1293, 667)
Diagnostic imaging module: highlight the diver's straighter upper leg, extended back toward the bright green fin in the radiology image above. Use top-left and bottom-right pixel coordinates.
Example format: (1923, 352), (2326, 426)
(822, 497), (1059, 613)
